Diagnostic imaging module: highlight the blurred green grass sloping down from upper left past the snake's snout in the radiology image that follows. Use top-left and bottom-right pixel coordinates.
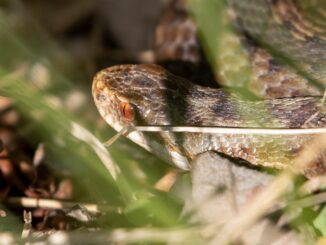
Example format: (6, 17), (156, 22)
(0, 1), (194, 242)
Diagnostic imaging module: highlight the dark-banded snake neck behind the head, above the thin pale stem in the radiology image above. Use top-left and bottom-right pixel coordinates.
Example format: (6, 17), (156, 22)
(158, 86), (326, 128)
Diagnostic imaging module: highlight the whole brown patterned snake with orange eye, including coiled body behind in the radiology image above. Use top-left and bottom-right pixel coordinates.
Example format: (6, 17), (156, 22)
(92, 0), (326, 176)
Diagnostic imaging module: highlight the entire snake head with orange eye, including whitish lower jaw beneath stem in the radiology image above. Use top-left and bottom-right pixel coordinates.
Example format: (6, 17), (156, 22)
(92, 65), (194, 170)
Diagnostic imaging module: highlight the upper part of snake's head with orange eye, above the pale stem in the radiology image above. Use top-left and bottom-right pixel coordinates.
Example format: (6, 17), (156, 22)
(93, 65), (189, 130)
